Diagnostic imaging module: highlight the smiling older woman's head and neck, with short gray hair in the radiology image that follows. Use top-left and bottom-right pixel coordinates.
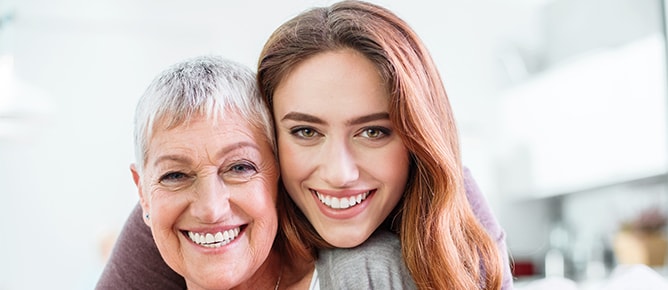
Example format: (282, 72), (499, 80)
(126, 57), (313, 289)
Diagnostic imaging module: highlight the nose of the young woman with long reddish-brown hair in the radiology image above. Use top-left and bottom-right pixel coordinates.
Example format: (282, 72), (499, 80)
(320, 142), (359, 187)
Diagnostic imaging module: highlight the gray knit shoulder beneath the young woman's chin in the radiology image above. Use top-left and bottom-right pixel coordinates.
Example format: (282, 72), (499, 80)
(316, 230), (416, 289)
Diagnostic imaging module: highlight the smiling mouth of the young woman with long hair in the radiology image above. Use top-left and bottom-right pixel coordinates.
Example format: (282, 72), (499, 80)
(311, 189), (376, 219)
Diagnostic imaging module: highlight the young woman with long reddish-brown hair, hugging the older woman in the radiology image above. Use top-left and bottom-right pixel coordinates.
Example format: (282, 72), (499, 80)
(95, 1), (512, 289)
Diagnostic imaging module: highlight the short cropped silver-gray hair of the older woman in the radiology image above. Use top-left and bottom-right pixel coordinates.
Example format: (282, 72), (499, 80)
(134, 56), (276, 172)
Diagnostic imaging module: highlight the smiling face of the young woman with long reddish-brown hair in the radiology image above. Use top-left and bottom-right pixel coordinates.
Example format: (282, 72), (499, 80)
(274, 49), (409, 247)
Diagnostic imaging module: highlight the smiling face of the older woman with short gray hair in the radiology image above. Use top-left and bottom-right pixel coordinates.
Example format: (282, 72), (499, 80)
(133, 113), (278, 288)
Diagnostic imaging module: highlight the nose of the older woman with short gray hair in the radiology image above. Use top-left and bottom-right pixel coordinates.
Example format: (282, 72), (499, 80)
(191, 175), (230, 223)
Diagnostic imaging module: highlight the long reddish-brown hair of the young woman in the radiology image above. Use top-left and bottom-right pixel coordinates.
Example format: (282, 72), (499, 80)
(258, 1), (503, 289)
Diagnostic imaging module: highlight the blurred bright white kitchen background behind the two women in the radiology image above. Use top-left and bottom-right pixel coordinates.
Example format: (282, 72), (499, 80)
(0, 0), (668, 289)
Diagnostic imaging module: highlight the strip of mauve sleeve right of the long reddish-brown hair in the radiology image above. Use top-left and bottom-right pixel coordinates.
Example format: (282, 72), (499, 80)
(464, 168), (513, 290)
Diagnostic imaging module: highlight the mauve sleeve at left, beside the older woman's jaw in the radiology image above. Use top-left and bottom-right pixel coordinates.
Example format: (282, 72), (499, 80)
(95, 205), (186, 290)
